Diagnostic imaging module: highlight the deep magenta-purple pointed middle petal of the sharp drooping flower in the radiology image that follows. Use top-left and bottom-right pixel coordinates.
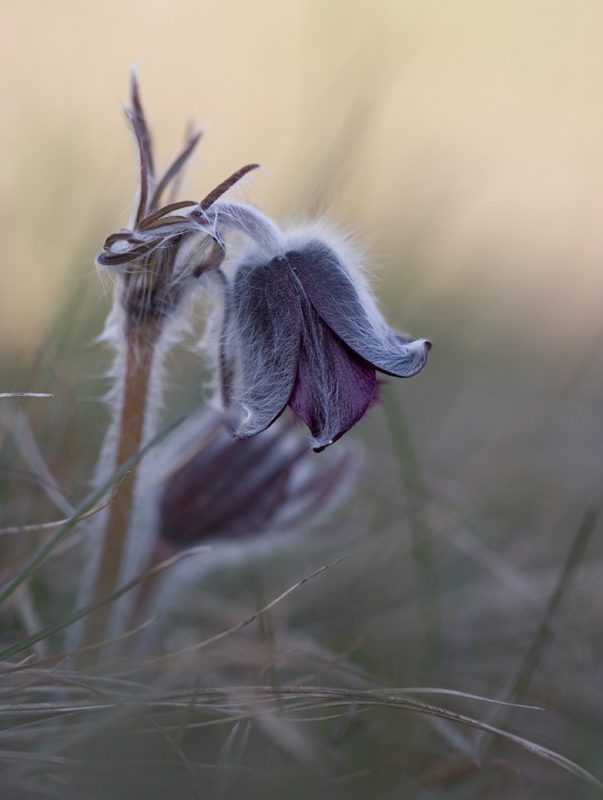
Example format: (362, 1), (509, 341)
(289, 300), (376, 452)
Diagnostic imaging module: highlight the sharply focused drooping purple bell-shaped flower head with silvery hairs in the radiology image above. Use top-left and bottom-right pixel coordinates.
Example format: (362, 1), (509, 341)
(223, 236), (431, 452)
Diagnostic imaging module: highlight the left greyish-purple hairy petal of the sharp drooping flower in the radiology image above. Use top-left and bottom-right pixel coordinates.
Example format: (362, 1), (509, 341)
(226, 257), (301, 436)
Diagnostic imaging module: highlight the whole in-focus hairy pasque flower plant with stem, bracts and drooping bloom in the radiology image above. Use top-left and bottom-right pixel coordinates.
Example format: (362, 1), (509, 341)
(82, 70), (429, 656)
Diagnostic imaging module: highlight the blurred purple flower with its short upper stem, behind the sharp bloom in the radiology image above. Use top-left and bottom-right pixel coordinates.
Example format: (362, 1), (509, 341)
(131, 410), (361, 636)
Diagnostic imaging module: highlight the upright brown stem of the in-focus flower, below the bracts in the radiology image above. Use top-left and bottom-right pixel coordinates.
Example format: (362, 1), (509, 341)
(81, 321), (161, 665)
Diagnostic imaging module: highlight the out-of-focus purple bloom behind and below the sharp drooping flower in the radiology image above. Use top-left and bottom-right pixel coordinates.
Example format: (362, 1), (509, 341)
(158, 414), (358, 556)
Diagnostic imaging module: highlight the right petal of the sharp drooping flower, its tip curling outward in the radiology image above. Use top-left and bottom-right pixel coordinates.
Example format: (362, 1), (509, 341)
(285, 242), (430, 378)
